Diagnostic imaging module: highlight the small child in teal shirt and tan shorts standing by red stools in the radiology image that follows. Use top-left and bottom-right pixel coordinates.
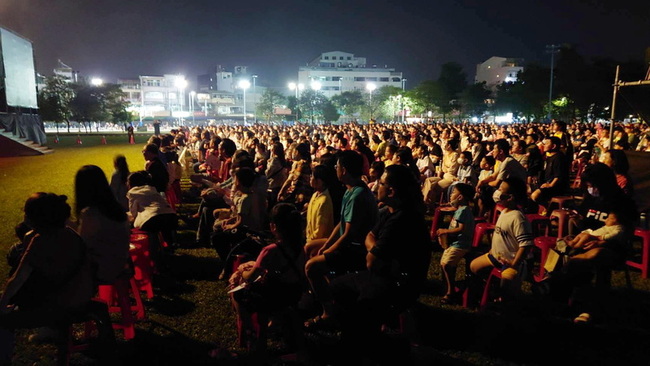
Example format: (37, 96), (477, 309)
(436, 183), (474, 304)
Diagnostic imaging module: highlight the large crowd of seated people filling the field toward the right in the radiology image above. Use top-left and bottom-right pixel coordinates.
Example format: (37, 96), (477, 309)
(3, 121), (650, 364)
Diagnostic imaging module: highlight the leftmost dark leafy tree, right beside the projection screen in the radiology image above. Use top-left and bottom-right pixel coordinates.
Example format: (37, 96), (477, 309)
(38, 75), (74, 132)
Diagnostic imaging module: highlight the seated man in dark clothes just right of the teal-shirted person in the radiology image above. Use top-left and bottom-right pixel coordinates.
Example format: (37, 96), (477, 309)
(316, 165), (431, 361)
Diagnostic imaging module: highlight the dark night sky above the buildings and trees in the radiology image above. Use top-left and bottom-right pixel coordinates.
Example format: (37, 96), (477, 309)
(0, 0), (650, 88)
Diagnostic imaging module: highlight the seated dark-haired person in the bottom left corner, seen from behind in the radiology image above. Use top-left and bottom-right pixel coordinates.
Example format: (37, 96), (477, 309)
(0, 192), (94, 364)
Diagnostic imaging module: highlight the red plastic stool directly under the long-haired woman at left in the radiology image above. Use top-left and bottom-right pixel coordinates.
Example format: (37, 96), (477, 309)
(99, 277), (145, 340)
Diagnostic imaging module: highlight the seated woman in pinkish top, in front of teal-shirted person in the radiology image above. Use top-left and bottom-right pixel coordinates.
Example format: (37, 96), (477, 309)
(230, 203), (306, 352)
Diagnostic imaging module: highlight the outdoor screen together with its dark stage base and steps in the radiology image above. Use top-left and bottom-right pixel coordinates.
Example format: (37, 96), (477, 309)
(0, 27), (46, 156)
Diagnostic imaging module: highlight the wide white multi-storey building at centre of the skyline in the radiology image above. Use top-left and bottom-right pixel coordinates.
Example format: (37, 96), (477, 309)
(298, 51), (406, 98)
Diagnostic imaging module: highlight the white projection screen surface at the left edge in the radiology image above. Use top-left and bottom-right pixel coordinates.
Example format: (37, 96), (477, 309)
(0, 28), (38, 109)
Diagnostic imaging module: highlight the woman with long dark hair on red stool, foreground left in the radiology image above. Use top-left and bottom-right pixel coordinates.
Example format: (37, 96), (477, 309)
(75, 165), (130, 284)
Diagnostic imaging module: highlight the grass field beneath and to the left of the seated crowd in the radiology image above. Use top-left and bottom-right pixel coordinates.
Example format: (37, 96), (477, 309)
(0, 134), (650, 365)
